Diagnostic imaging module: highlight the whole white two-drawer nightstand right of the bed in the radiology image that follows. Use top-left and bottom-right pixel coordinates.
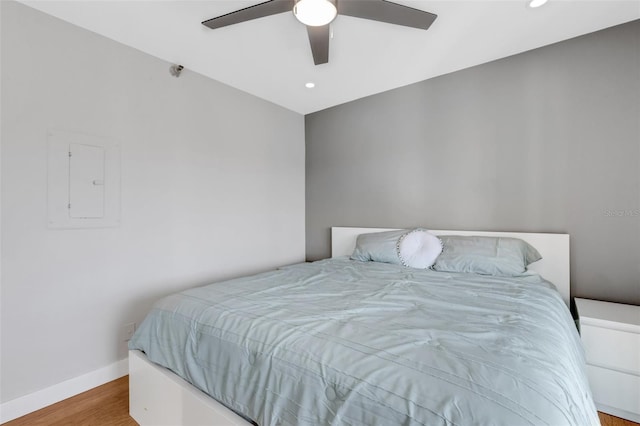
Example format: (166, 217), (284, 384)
(575, 299), (640, 423)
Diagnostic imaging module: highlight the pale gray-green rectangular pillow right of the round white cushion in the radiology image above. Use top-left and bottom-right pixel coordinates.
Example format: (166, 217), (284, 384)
(433, 235), (542, 276)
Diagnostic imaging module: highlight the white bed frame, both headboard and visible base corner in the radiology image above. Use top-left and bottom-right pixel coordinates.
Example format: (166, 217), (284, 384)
(129, 227), (570, 426)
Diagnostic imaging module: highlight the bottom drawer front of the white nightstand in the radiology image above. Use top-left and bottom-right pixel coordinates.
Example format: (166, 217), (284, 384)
(587, 365), (640, 420)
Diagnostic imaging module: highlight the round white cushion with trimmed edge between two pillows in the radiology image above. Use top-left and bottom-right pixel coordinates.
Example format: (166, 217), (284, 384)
(397, 229), (442, 269)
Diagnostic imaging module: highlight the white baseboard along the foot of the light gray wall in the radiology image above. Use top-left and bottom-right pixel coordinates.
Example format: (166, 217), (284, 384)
(0, 359), (129, 423)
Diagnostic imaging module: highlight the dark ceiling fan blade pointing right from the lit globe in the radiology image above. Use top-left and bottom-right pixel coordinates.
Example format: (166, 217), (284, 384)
(337, 0), (438, 30)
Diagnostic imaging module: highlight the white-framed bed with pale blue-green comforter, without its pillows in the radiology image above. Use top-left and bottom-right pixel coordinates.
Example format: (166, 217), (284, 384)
(129, 228), (598, 426)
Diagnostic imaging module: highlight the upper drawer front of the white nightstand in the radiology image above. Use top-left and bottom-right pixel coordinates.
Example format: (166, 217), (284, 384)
(581, 325), (640, 375)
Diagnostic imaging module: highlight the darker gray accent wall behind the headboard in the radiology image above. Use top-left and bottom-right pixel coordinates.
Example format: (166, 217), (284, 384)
(306, 21), (640, 304)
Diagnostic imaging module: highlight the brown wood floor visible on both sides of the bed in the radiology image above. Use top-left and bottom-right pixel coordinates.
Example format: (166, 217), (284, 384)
(3, 376), (640, 426)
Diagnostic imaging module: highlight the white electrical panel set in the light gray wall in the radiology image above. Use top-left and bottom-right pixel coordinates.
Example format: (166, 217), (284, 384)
(47, 131), (120, 228)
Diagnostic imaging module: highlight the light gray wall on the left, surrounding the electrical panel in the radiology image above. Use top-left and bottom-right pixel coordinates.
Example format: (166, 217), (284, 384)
(0, 1), (305, 402)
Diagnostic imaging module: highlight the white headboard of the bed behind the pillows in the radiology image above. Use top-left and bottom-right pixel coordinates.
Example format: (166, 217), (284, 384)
(331, 227), (571, 306)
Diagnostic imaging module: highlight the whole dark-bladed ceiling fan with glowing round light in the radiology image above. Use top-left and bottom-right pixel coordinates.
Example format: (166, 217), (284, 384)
(202, 0), (437, 65)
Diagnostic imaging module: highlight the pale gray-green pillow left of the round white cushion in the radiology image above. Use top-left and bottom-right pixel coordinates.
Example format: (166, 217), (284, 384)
(351, 229), (409, 265)
